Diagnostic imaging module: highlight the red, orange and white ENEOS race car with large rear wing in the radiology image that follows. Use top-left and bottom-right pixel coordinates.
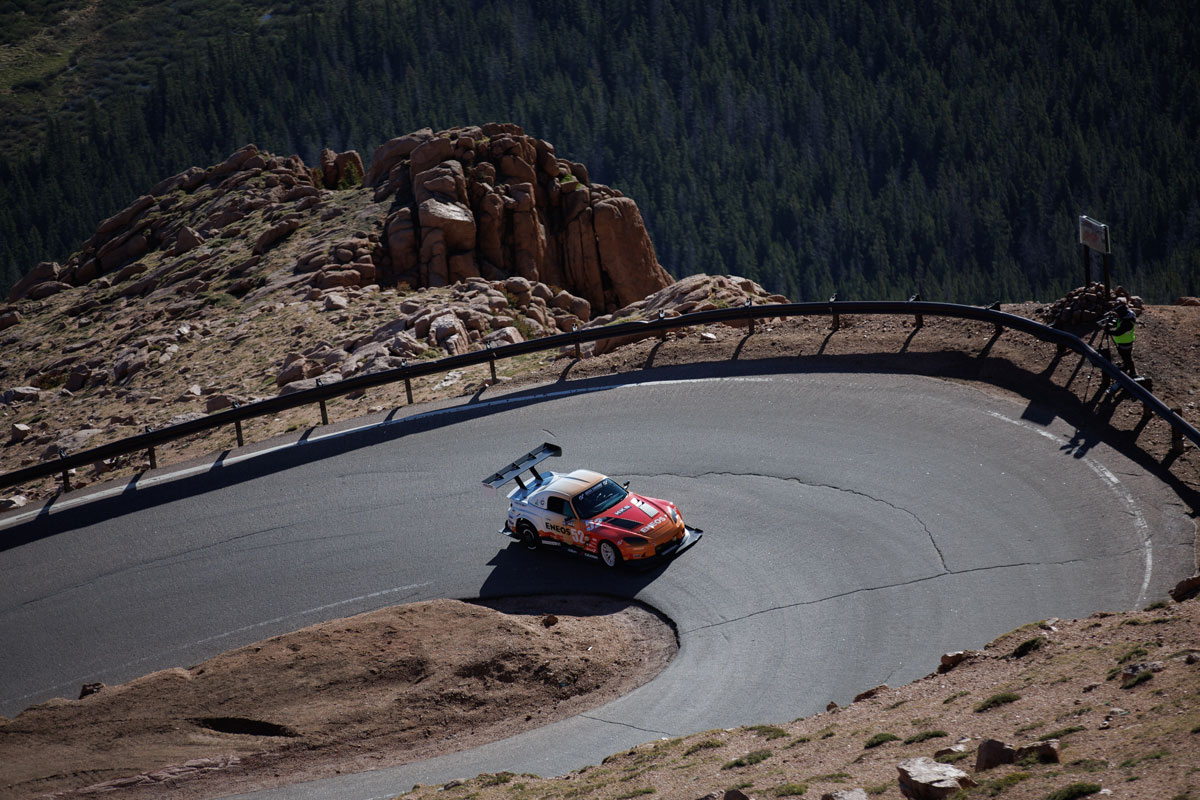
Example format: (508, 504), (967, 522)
(484, 441), (704, 567)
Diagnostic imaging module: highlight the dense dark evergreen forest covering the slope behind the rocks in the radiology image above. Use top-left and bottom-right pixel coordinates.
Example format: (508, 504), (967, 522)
(0, 0), (1200, 302)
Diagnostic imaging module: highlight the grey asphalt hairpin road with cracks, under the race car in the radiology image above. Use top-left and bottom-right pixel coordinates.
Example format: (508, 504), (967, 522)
(0, 365), (1194, 799)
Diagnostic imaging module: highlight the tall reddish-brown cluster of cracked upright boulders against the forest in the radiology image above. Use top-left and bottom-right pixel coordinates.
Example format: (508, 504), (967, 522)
(364, 124), (671, 311)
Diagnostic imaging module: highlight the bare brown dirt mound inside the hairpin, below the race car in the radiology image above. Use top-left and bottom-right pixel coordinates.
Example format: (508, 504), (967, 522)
(0, 596), (677, 799)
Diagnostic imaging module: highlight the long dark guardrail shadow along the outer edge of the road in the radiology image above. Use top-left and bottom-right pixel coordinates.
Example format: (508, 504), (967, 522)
(0, 350), (1200, 552)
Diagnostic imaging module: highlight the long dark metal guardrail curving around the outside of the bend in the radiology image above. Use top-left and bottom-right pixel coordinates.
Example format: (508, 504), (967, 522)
(0, 300), (1200, 488)
